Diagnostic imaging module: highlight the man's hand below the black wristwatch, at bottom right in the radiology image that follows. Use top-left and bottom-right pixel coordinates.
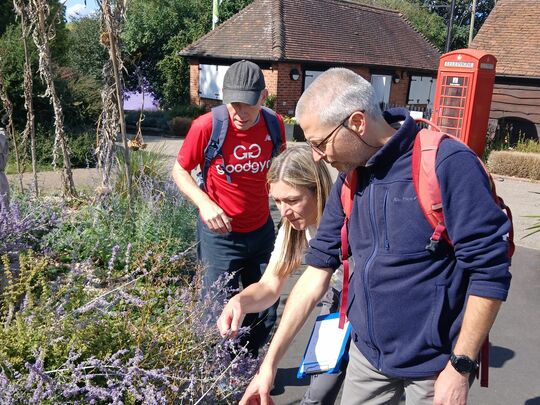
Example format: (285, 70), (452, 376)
(433, 362), (469, 405)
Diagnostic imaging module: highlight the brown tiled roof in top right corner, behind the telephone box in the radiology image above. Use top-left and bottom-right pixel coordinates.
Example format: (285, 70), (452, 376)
(471, 0), (540, 77)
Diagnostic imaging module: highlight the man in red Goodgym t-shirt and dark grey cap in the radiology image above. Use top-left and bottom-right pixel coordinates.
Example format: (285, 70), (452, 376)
(172, 60), (286, 355)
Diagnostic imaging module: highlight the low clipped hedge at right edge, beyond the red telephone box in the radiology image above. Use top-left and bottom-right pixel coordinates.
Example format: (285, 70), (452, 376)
(487, 151), (540, 180)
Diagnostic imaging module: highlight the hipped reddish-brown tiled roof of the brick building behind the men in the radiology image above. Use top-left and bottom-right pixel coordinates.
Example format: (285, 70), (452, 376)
(180, 0), (440, 70)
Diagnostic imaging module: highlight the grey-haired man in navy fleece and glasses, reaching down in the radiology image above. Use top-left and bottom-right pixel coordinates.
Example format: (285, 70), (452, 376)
(240, 69), (511, 405)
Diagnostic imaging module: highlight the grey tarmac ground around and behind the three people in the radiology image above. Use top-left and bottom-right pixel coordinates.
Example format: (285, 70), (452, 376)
(8, 136), (540, 405)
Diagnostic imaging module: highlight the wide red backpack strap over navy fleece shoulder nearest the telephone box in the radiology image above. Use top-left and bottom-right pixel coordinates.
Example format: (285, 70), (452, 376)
(412, 129), (452, 252)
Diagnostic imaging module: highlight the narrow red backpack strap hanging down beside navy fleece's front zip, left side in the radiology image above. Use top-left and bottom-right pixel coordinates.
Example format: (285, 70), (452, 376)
(339, 170), (358, 329)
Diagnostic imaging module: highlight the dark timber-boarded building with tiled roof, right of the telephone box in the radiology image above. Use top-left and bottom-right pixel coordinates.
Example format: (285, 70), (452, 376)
(471, 0), (540, 141)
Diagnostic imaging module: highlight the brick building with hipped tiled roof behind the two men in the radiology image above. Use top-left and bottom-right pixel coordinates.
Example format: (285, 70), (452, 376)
(180, 0), (440, 115)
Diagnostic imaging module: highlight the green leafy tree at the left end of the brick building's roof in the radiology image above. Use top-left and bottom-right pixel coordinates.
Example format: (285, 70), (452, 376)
(123, 0), (252, 107)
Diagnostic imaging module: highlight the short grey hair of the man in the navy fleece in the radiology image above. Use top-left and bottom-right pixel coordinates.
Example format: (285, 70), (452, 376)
(296, 68), (383, 125)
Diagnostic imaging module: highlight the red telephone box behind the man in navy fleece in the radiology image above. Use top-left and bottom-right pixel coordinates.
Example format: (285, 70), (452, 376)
(431, 49), (497, 156)
